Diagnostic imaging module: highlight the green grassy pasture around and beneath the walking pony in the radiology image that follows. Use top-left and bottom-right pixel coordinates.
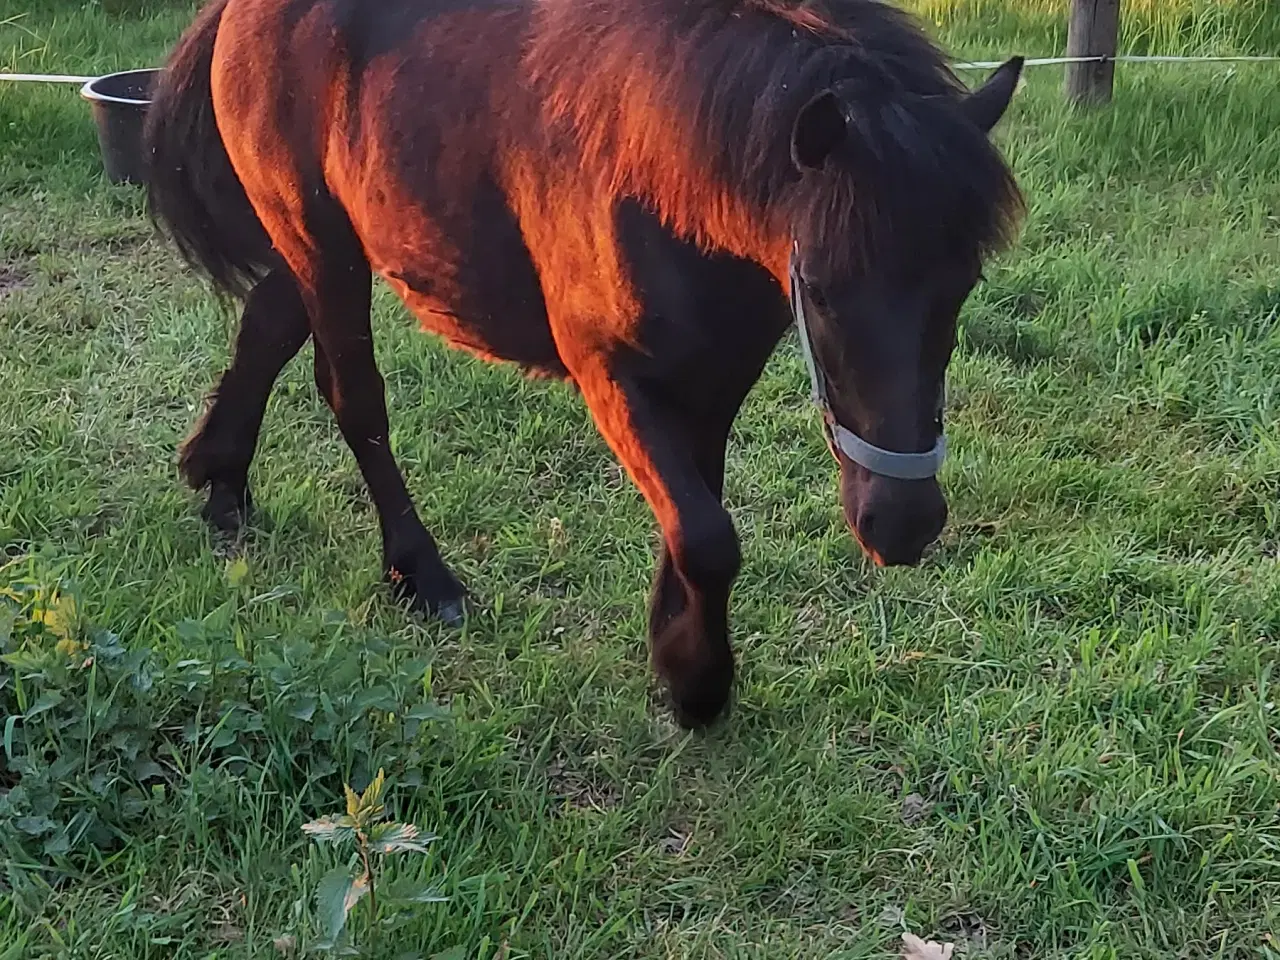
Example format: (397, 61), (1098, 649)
(0, 0), (1280, 960)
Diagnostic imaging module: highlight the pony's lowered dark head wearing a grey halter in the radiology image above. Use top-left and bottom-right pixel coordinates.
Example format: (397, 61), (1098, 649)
(790, 58), (1023, 564)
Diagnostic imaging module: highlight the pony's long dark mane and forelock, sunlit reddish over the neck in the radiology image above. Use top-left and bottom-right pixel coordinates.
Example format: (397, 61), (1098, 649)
(527, 0), (1021, 271)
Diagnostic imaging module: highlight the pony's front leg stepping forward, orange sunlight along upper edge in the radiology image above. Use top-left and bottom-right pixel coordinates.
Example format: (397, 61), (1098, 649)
(573, 361), (741, 727)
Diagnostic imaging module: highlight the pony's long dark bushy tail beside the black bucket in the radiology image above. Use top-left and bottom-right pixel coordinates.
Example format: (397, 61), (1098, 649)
(143, 0), (274, 297)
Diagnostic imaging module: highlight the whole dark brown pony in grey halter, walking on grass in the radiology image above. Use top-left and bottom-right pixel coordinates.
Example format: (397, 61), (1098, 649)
(147, 0), (1021, 726)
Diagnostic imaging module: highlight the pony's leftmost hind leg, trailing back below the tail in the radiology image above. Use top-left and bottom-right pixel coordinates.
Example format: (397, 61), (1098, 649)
(178, 268), (311, 535)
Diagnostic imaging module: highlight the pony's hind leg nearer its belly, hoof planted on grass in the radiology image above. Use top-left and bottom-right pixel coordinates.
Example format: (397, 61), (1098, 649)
(276, 198), (466, 623)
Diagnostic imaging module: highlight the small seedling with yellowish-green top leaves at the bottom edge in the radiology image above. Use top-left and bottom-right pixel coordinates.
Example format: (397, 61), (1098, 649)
(302, 769), (447, 956)
